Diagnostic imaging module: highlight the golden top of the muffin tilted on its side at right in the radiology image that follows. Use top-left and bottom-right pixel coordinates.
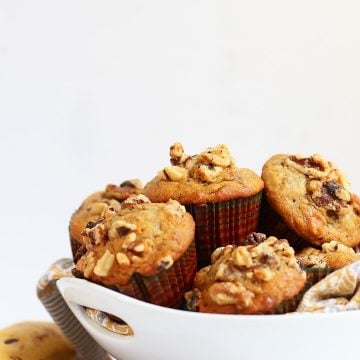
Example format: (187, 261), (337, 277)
(262, 154), (360, 247)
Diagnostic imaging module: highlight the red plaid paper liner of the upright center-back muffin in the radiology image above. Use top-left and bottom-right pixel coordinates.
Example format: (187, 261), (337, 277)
(185, 191), (262, 269)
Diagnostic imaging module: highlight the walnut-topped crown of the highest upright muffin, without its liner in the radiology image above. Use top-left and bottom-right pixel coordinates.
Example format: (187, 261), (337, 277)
(144, 143), (264, 205)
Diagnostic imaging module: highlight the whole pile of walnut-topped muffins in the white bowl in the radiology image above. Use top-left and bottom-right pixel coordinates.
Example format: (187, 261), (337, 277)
(70, 143), (360, 314)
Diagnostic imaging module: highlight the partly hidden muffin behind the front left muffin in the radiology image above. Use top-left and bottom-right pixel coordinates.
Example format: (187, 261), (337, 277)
(69, 179), (143, 262)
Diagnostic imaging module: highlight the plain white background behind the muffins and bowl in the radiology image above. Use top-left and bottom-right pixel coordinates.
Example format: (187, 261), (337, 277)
(0, 0), (360, 327)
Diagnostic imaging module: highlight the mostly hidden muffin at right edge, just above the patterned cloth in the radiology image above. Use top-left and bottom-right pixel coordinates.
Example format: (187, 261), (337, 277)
(296, 240), (360, 289)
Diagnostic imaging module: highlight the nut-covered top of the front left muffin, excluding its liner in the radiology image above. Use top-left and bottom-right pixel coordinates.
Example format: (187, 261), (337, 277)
(76, 195), (195, 285)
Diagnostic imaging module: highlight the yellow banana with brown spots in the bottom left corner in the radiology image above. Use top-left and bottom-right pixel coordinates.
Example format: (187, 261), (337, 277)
(0, 321), (75, 360)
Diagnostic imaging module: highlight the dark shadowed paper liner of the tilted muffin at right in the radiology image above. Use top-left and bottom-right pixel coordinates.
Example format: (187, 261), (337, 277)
(259, 196), (311, 251)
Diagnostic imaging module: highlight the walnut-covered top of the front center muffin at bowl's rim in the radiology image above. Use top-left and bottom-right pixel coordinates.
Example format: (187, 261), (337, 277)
(186, 234), (306, 314)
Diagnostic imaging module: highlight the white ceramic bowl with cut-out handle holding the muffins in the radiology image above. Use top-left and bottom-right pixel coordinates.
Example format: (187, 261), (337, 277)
(57, 278), (360, 360)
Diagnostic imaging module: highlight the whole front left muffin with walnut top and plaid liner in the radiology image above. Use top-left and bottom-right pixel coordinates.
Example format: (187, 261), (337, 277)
(74, 195), (196, 307)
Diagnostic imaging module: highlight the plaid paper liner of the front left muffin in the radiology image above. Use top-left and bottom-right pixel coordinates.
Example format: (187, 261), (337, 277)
(110, 241), (196, 308)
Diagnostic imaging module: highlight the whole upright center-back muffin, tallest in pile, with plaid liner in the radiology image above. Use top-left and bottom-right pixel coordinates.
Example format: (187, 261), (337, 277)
(143, 143), (264, 267)
